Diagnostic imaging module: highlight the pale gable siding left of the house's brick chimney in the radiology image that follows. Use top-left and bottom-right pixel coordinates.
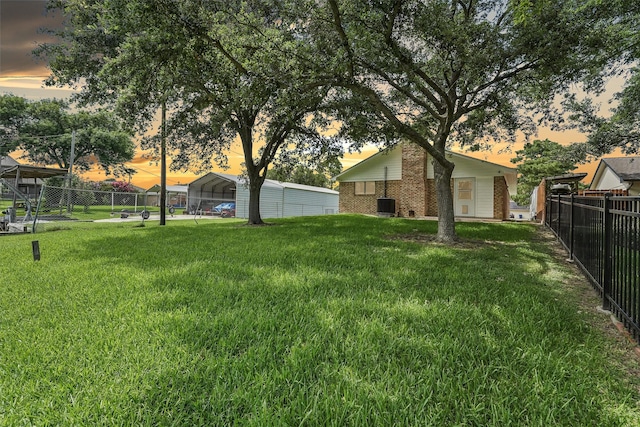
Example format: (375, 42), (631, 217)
(338, 145), (402, 182)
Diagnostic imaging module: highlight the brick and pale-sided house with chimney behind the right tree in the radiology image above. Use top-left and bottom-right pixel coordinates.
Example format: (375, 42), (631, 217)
(336, 143), (517, 219)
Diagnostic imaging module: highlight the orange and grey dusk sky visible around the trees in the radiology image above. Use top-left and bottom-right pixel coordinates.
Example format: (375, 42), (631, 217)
(0, 0), (619, 188)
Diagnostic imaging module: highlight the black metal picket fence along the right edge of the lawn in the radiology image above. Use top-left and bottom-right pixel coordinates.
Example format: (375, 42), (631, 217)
(545, 194), (640, 343)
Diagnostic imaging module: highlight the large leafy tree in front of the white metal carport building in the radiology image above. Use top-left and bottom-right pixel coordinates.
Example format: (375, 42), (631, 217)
(40, 0), (340, 224)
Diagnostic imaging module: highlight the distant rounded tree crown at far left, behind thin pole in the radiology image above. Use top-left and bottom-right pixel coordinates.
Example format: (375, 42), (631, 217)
(0, 95), (135, 175)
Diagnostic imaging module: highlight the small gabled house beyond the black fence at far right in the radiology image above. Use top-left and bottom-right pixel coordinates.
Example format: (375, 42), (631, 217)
(589, 156), (640, 196)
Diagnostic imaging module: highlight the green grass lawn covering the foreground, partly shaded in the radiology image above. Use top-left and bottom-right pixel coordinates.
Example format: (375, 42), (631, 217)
(0, 215), (640, 426)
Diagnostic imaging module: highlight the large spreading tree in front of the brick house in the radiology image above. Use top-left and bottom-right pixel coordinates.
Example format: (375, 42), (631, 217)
(299, 0), (607, 241)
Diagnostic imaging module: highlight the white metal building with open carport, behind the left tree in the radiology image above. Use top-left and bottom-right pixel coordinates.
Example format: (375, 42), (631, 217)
(187, 172), (338, 218)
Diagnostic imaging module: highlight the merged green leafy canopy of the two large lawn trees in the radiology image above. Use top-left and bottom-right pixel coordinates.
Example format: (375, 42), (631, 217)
(35, 0), (627, 231)
